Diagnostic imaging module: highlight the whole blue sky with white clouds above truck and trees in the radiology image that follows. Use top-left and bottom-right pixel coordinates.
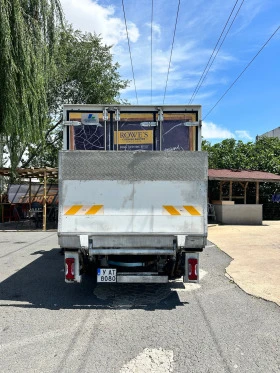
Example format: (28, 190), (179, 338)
(60, 0), (280, 143)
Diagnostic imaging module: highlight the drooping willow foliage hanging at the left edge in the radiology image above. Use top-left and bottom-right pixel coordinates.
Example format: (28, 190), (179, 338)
(0, 0), (62, 141)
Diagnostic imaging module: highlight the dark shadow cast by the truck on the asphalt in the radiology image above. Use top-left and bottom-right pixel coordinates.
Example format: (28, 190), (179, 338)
(0, 249), (186, 311)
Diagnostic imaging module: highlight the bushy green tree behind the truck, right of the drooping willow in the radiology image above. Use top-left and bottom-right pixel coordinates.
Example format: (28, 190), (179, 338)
(4, 26), (128, 167)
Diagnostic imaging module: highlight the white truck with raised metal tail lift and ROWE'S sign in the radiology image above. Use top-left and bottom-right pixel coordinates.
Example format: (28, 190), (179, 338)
(58, 105), (208, 283)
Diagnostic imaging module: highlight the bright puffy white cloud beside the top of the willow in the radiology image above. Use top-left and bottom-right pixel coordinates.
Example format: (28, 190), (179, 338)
(60, 0), (140, 45)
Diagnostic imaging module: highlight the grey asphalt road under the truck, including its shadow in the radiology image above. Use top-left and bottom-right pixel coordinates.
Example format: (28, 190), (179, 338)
(0, 232), (280, 373)
